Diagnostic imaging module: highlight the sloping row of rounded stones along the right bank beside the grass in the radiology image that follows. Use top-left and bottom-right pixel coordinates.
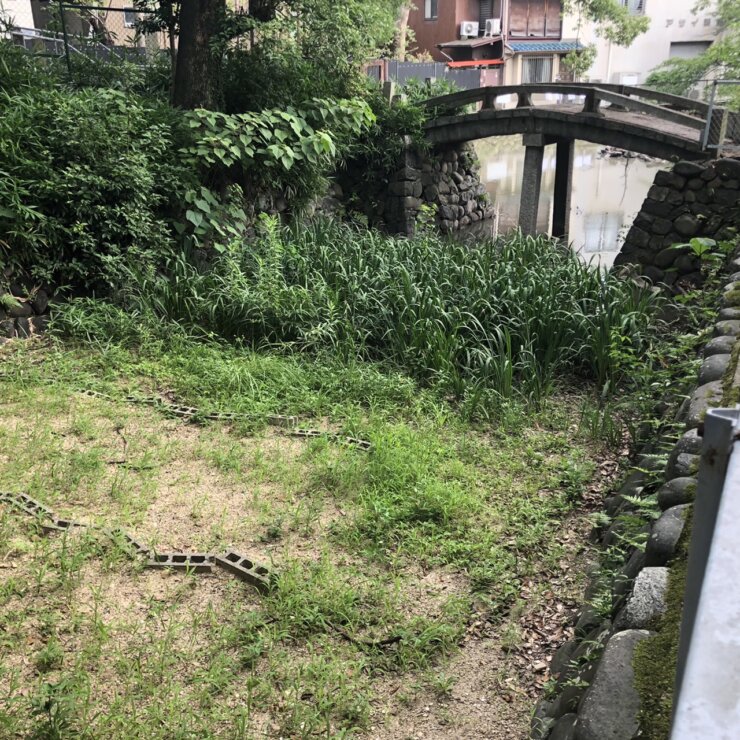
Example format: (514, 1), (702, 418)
(531, 251), (740, 740)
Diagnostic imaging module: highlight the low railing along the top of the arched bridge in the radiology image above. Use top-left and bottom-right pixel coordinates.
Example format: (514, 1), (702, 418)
(424, 82), (717, 143)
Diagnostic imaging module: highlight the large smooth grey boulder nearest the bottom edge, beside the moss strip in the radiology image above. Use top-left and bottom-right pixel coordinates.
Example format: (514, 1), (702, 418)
(575, 630), (650, 740)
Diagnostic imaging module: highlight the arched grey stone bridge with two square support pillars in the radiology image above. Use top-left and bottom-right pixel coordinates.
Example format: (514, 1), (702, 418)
(424, 83), (724, 237)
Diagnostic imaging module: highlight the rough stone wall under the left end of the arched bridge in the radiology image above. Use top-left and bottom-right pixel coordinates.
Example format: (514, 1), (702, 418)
(340, 143), (493, 236)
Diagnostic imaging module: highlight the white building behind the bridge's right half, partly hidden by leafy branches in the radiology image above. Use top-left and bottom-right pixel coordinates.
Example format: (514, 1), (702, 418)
(563, 0), (719, 85)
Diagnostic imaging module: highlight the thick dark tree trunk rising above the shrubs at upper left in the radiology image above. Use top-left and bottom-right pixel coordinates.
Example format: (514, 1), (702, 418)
(172, 0), (226, 110)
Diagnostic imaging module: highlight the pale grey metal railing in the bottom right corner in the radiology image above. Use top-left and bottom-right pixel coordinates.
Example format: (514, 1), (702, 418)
(671, 407), (740, 740)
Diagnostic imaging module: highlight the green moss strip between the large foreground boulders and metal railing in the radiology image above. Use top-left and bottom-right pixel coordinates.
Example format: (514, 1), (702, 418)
(633, 520), (691, 740)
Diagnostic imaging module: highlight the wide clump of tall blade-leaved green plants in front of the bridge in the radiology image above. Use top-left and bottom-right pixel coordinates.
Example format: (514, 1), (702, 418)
(114, 219), (658, 410)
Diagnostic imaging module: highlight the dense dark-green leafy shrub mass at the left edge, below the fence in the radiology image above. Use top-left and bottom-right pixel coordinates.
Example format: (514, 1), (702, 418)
(0, 88), (188, 287)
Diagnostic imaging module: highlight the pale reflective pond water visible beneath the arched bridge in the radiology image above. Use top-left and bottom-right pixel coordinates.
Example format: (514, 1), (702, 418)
(476, 136), (665, 267)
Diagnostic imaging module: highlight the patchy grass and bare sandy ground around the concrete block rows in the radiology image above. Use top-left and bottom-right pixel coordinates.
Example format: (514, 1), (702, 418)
(0, 339), (608, 738)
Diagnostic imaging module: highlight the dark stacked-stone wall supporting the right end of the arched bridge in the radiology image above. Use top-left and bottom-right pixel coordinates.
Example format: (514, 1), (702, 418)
(614, 159), (740, 286)
